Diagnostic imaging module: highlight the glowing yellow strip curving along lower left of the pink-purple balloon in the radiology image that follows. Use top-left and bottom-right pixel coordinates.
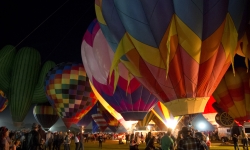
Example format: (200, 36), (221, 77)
(89, 82), (138, 130)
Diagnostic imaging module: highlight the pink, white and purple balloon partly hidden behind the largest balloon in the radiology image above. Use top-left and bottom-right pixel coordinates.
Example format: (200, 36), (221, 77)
(81, 20), (158, 120)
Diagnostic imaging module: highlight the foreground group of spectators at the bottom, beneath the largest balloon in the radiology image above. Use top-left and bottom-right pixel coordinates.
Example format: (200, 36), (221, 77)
(130, 127), (211, 150)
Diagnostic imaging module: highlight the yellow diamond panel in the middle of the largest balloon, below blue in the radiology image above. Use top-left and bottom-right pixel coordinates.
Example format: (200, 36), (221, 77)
(175, 15), (202, 63)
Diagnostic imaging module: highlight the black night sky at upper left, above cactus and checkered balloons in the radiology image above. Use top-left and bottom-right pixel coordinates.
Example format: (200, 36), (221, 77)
(0, 0), (95, 63)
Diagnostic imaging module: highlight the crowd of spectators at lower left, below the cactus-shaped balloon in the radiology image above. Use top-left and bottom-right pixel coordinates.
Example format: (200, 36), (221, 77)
(0, 123), (86, 150)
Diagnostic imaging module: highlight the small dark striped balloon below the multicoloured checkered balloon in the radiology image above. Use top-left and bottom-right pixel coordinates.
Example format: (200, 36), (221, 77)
(33, 102), (59, 131)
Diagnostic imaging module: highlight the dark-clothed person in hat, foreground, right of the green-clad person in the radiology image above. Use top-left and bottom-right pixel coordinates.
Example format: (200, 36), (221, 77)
(177, 127), (204, 150)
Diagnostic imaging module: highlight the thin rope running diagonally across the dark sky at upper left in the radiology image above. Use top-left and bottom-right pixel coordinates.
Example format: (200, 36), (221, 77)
(0, 0), (69, 61)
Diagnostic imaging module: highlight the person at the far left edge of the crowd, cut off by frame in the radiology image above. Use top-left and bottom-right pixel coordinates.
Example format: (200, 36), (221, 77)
(0, 127), (10, 150)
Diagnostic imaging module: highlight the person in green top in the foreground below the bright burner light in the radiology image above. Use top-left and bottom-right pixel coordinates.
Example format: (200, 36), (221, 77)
(160, 129), (174, 150)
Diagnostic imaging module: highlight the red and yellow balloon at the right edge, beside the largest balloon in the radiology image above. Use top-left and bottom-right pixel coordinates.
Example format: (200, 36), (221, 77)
(213, 68), (250, 124)
